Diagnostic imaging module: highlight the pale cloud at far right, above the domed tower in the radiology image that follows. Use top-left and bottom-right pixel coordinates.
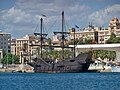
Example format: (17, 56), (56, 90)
(88, 4), (120, 26)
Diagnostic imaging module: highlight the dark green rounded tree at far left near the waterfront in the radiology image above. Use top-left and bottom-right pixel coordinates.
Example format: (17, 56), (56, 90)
(1, 53), (19, 64)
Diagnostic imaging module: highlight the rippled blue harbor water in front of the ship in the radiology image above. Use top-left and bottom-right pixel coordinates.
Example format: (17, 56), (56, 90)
(0, 73), (120, 90)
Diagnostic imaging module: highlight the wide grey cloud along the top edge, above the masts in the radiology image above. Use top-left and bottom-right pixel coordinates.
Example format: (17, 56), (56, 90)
(16, 0), (88, 16)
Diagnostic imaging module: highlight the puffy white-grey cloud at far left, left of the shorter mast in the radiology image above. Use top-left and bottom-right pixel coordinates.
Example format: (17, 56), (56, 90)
(0, 7), (39, 37)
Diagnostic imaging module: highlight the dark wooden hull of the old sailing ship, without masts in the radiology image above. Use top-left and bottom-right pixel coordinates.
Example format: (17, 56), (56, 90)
(28, 52), (92, 73)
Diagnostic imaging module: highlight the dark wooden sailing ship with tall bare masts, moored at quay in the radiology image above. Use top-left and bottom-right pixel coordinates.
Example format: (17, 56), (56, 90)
(28, 11), (92, 73)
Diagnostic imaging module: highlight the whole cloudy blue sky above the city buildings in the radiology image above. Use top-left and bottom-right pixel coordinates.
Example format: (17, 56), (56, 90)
(0, 0), (120, 38)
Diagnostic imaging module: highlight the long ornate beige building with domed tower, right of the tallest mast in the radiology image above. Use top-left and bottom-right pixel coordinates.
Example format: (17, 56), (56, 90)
(69, 18), (120, 44)
